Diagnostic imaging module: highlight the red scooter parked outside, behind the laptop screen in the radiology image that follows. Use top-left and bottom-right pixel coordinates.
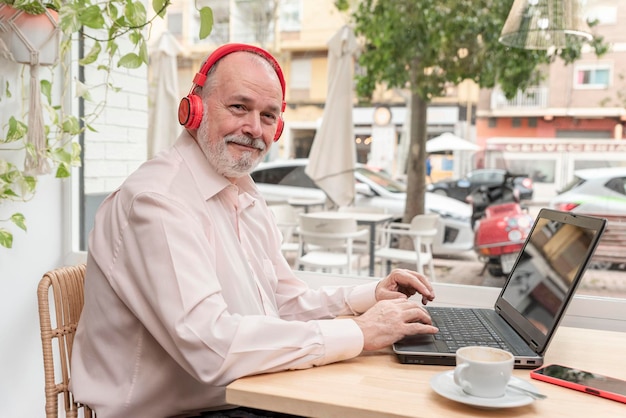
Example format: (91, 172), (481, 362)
(467, 172), (533, 277)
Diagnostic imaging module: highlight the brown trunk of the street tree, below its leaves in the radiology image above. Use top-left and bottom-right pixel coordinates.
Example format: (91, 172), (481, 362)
(404, 91), (428, 222)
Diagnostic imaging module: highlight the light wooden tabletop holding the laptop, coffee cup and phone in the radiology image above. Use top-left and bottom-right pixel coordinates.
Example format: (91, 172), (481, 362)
(226, 327), (626, 418)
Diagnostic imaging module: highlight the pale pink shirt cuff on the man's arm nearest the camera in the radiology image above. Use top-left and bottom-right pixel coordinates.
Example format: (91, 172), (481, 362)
(318, 319), (364, 364)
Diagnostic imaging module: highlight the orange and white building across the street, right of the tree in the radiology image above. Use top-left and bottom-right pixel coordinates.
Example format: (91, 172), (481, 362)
(476, 0), (626, 200)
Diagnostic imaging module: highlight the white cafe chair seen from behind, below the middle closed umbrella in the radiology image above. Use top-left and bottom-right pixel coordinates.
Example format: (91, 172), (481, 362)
(296, 213), (369, 274)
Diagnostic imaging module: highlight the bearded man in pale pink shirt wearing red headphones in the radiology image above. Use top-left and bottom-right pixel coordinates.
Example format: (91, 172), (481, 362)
(72, 44), (437, 418)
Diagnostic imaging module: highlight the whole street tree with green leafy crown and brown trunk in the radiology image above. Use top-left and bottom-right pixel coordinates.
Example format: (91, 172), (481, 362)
(335, 0), (607, 221)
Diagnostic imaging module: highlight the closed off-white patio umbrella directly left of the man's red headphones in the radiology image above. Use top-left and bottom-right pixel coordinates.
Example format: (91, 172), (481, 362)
(148, 32), (182, 158)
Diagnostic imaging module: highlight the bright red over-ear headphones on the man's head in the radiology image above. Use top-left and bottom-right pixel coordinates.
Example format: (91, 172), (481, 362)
(178, 44), (286, 141)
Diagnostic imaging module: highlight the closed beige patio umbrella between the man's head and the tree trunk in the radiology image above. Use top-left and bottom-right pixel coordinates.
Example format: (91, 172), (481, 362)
(306, 26), (357, 206)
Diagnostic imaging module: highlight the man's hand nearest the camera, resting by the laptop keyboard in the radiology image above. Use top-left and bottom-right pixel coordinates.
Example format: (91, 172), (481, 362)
(354, 297), (439, 350)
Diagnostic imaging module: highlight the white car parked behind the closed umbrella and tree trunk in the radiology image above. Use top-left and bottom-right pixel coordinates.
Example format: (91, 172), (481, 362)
(251, 159), (474, 255)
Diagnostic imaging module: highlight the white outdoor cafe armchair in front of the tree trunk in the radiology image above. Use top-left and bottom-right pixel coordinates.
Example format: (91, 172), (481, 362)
(376, 214), (439, 281)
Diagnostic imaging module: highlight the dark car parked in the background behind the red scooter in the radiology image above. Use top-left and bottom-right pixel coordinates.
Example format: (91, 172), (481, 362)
(427, 168), (533, 202)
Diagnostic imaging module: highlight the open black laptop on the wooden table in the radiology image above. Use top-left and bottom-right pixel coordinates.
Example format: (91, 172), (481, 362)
(393, 209), (607, 369)
